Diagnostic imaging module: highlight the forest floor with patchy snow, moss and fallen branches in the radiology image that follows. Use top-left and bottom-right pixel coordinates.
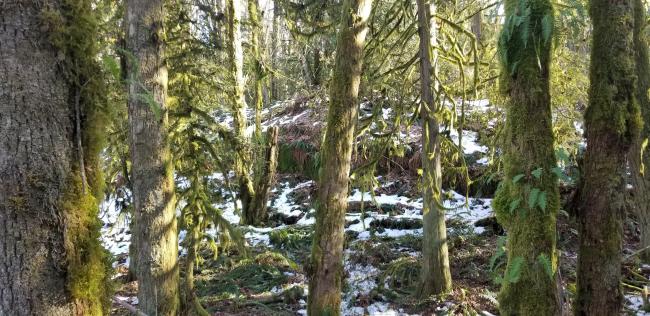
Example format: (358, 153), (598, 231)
(102, 97), (650, 315)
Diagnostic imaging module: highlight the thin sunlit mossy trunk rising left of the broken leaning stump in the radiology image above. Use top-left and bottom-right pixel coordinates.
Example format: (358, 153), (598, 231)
(226, 0), (261, 224)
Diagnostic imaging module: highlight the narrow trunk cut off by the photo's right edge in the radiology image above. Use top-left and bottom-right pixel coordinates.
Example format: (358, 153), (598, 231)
(630, 0), (650, 263)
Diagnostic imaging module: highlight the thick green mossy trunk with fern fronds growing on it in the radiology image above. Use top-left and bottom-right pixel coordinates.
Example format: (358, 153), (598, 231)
(493, 0), (562, 315)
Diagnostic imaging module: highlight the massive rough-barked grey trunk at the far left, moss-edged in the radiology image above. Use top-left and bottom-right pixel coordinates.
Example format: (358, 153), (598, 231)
(0, 0), (107, 316)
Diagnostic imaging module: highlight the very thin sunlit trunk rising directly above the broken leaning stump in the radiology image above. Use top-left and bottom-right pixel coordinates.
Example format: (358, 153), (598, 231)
(248, 0), (265, 142)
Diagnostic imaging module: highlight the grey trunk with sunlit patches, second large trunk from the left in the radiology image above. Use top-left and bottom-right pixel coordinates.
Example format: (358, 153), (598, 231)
(126, 0), (180, 315)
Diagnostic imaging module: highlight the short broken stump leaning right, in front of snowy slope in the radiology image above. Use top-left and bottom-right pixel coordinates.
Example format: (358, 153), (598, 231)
(246, 126), (280, 225)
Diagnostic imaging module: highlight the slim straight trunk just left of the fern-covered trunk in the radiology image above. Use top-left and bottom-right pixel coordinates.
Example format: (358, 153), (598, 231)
(417, 0), (451, 297)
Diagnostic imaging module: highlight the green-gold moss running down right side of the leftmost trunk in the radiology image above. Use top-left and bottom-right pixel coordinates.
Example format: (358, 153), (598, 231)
(41, 0), (112, 315)
